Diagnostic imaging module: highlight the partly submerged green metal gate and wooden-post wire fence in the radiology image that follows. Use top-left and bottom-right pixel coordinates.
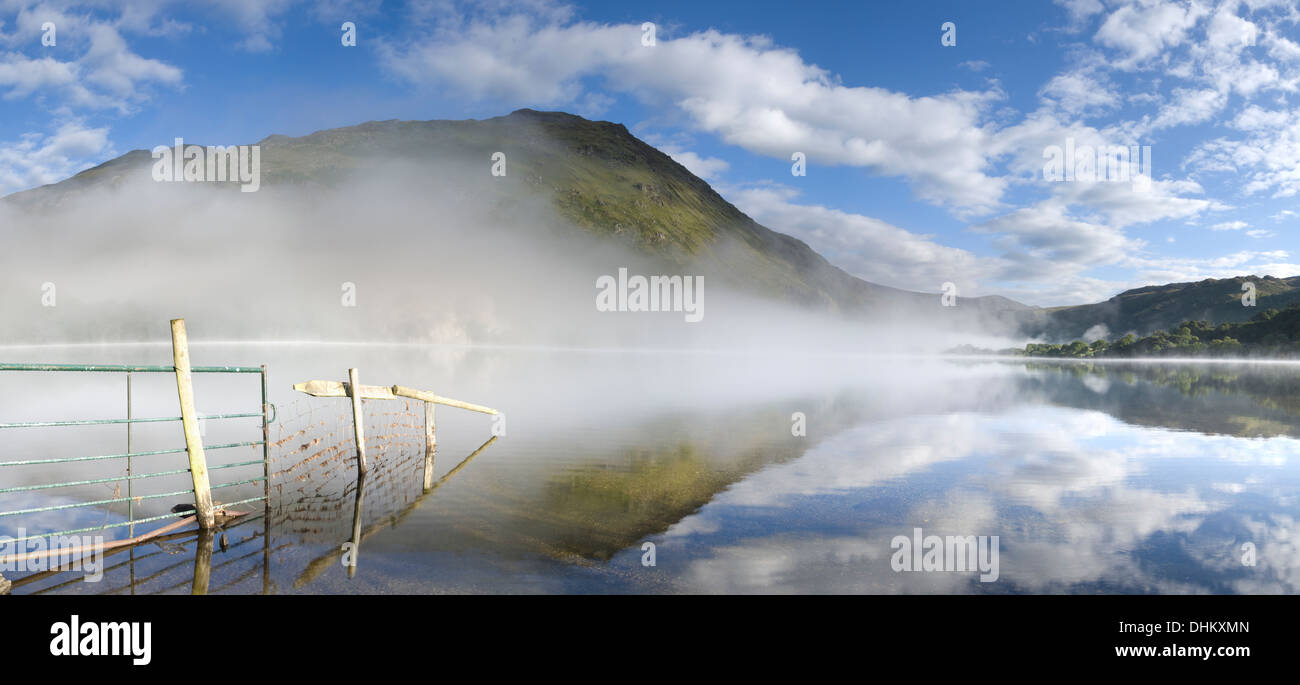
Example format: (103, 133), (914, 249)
(0, 318), (503, 594)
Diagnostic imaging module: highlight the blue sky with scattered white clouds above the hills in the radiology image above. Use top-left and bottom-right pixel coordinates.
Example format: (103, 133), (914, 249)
(0, 0), (1300, 305)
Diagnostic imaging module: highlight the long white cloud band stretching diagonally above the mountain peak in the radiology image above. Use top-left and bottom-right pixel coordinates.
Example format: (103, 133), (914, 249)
(381, 3), (1006, 211)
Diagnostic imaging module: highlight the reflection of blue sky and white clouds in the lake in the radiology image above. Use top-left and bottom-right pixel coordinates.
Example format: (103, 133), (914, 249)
(659, 365), (1300, 593)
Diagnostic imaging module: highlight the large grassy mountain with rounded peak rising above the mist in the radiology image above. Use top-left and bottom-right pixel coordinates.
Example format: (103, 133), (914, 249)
(5, 109), (1031, 324)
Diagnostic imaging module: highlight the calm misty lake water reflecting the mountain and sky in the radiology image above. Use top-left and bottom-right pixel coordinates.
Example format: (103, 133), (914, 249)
(0, 344), (1300, 594)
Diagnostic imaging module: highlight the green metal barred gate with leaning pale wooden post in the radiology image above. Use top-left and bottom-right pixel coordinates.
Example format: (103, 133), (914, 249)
(0, 320), (273, 553)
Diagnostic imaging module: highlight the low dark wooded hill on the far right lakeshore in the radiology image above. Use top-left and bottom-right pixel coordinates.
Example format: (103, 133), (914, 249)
(1018, 276), (1300, 342)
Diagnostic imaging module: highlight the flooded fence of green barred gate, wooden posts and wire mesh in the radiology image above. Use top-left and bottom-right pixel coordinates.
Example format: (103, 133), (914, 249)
(0, 320), (499, 594)
